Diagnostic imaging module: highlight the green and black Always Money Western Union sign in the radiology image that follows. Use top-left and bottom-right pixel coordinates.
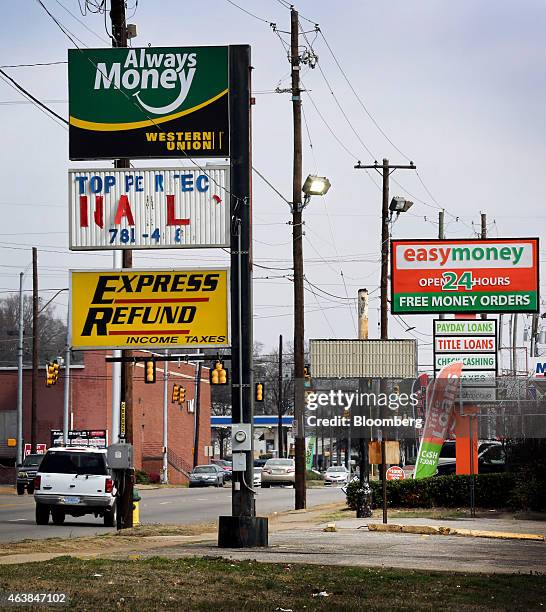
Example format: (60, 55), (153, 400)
(68, 47), (229, 159)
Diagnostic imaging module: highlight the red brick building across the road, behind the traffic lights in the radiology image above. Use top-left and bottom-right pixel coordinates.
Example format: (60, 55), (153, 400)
(0, 351), (211, 484)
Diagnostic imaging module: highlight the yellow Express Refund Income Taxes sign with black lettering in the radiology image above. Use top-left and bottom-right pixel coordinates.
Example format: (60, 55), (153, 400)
(70, 269), (229, 349)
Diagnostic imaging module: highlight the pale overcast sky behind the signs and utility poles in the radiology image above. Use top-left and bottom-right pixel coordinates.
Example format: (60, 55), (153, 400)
(0, 0), (546, 369)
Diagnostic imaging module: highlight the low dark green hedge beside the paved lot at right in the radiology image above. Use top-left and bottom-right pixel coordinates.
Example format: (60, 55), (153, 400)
(347, 474), (522, 510)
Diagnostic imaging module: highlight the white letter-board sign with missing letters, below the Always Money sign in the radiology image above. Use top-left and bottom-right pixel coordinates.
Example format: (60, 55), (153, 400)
(68, 166), (229, 250)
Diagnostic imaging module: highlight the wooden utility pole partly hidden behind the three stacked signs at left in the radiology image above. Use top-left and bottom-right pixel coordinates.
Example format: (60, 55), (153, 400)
(110, 0), (134, 529)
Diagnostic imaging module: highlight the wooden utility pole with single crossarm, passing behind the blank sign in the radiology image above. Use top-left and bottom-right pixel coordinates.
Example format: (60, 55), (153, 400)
(355, 158), (416, 523)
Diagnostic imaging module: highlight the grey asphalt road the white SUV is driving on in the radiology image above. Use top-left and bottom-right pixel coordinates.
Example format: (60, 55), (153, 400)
(0, 486), (344, 542)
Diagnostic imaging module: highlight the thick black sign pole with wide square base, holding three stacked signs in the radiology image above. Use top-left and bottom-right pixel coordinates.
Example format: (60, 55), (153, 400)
(218, 45), (268, 548)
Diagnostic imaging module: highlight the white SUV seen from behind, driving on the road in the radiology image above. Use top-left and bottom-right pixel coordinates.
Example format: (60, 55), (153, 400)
(34, 447), (116, 527)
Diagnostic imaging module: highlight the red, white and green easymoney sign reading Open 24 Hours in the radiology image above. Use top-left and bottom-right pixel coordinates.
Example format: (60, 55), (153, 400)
(391, 238), (538, 314)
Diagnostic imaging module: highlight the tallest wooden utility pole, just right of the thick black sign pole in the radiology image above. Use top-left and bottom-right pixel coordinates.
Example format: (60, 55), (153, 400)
(290, 8), (307, 510)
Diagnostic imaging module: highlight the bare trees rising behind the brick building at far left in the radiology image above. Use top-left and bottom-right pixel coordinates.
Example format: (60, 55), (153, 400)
(0, 295), (66, 367)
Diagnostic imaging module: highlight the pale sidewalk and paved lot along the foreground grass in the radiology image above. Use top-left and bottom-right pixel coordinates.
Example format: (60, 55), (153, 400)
(0, 505), (546, 574)
